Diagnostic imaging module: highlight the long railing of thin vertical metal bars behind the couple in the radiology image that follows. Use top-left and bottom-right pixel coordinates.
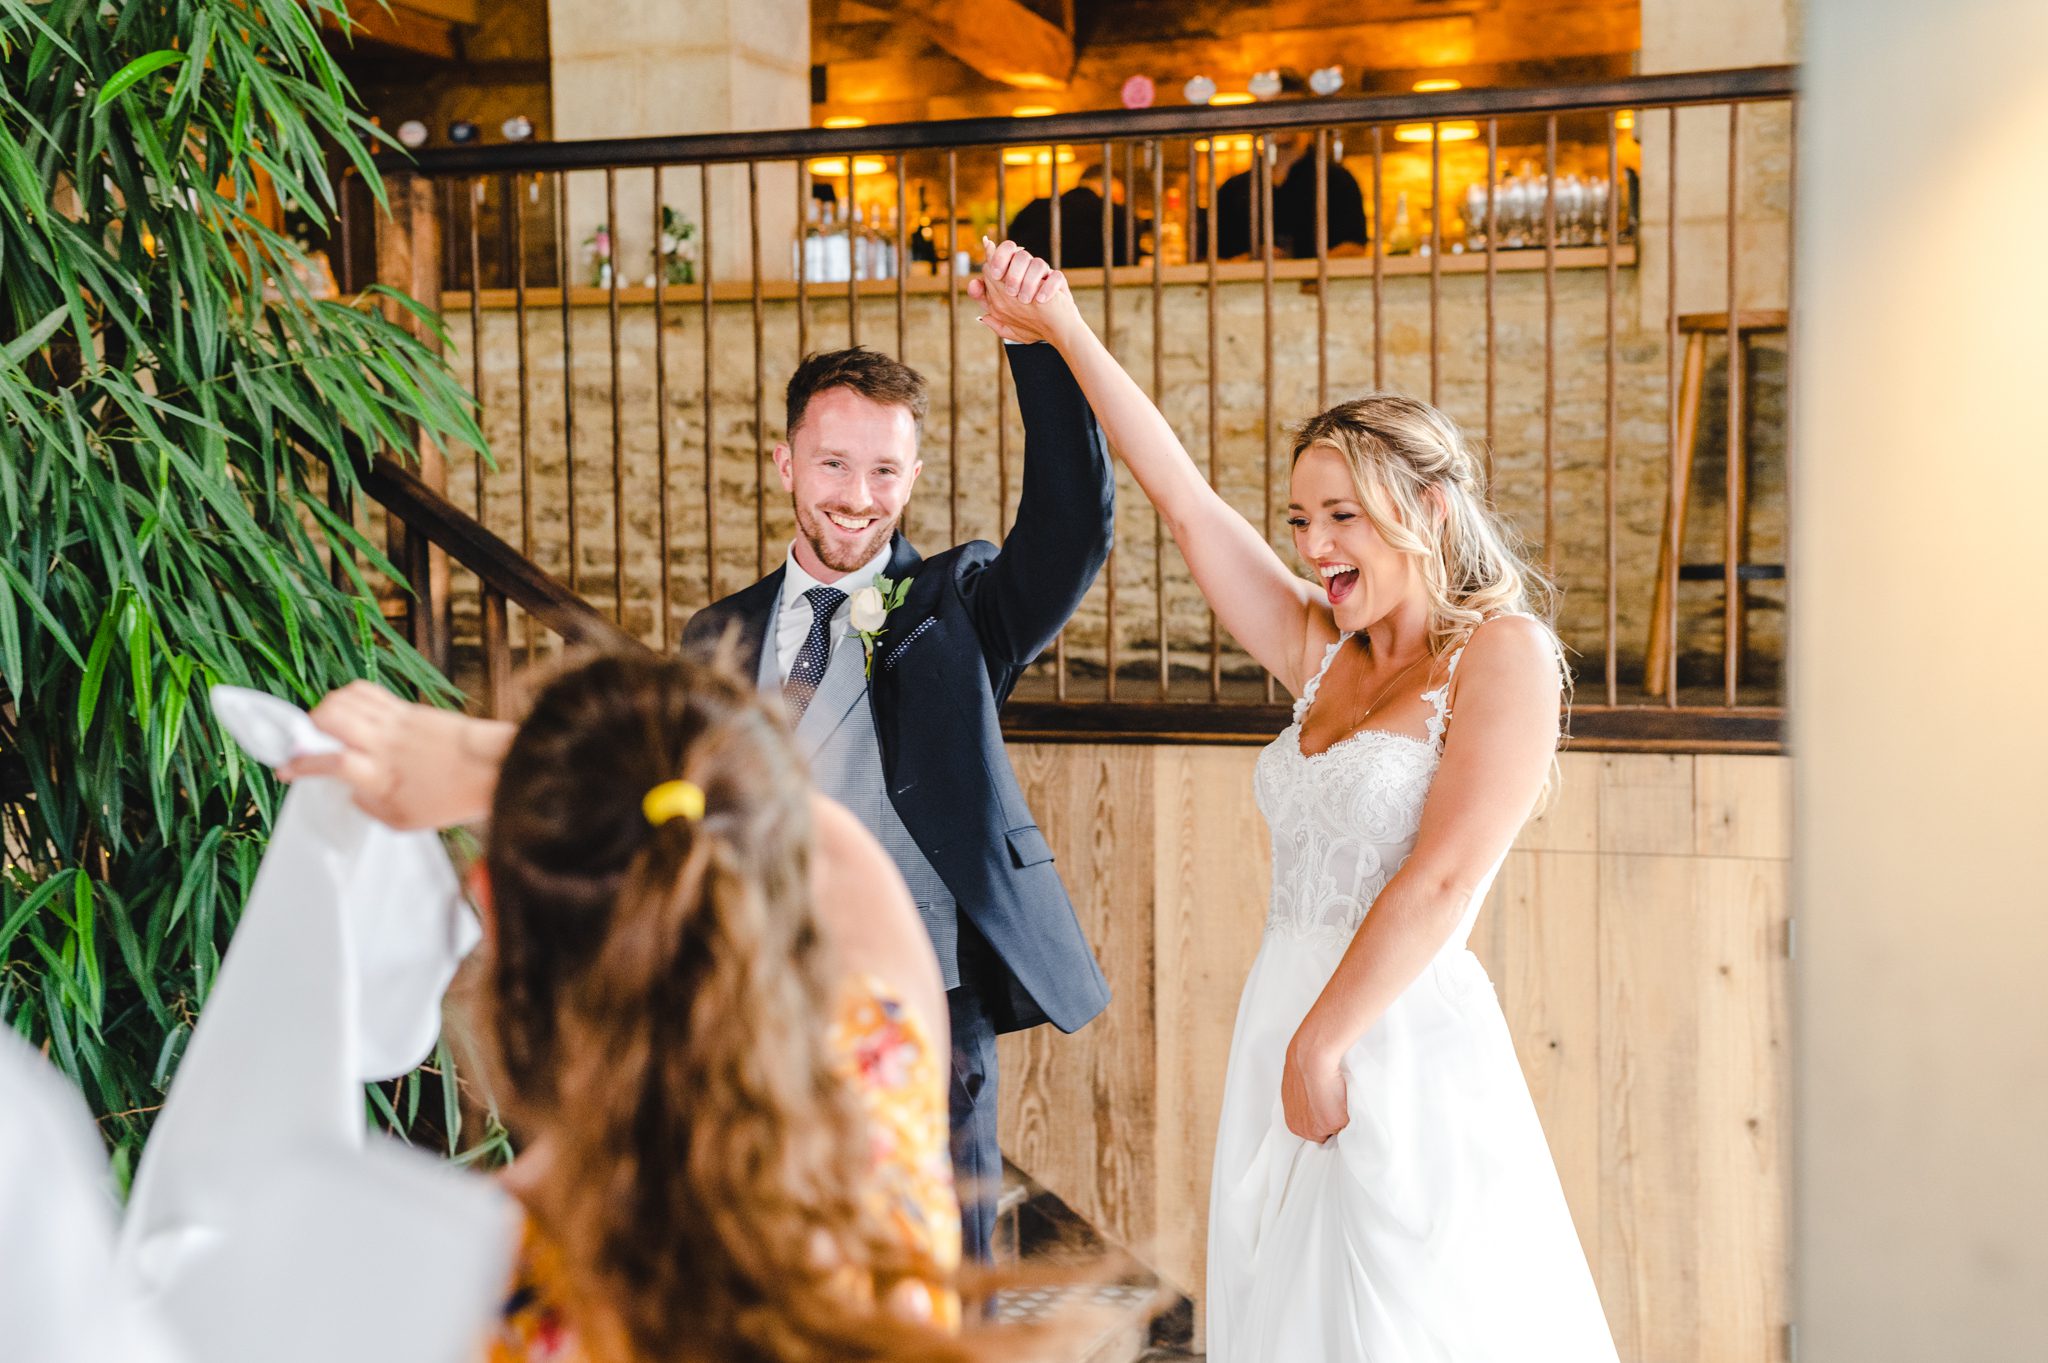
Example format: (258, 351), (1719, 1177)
(342, 68), (1794, 749)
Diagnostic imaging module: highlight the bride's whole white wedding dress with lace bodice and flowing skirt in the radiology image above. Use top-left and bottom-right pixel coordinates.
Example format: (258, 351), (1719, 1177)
(1208, 626), (1616, 1363)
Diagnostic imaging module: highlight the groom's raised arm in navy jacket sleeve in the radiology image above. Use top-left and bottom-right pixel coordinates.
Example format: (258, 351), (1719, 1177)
(967, 344), (1116, 667)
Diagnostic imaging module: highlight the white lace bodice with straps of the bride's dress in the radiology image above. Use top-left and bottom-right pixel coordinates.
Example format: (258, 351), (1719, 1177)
(1253, 634), (1473, 950)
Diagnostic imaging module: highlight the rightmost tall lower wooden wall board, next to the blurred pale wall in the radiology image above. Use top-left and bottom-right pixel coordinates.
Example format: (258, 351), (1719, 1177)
(1673, 855), (1792, 1363)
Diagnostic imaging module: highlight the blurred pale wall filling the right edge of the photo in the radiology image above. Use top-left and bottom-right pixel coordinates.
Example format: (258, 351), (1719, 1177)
(1792, 0), (2048, 1363)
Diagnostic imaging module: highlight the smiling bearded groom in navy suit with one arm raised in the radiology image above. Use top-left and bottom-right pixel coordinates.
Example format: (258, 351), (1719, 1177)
(684, 337), (1114, 1259)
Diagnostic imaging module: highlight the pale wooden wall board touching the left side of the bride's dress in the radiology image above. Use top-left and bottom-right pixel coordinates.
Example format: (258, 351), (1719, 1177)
(1151, 747), (1272, 1309)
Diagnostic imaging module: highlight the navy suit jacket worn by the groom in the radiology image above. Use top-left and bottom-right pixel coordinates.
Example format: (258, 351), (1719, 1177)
(682, 344), (1116, 1031)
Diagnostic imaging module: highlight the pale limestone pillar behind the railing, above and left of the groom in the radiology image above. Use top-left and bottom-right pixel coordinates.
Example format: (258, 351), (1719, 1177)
(549, 0), (811, 284)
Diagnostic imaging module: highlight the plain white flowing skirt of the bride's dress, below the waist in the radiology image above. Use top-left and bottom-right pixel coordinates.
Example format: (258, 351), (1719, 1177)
(1208, 931), (1616, 1363)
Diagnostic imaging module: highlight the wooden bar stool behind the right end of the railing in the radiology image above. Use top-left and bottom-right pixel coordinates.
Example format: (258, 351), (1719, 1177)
(1642, 309), (1786, 696)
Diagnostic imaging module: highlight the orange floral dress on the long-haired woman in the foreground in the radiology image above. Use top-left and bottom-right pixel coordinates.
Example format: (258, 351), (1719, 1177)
(483, 976), (961, 1363)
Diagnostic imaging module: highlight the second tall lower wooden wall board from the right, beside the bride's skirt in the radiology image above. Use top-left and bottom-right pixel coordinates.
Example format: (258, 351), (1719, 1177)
(1593, 851), (1706, 1363)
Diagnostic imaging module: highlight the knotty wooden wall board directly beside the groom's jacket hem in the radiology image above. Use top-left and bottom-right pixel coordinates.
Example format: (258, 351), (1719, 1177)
(997, 743), (1157, 1244)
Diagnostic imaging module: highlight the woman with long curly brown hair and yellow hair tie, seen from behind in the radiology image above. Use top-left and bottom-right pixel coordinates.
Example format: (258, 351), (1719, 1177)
(285, 655), (965, 1363)
